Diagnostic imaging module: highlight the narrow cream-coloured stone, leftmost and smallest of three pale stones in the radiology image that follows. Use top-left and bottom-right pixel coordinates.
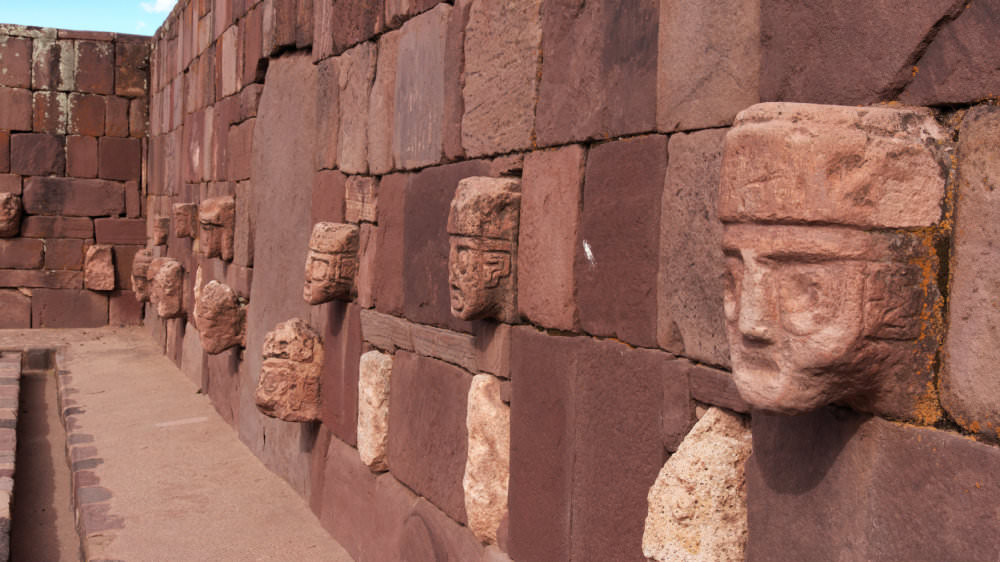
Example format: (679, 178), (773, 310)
(358, 351), (392, 471)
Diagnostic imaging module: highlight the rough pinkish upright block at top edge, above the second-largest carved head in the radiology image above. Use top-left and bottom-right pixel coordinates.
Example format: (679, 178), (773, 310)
(460, 0), (540, 156)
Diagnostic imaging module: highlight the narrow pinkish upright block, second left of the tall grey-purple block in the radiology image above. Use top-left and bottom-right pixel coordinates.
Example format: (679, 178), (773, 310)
(337, 42), (378, 174)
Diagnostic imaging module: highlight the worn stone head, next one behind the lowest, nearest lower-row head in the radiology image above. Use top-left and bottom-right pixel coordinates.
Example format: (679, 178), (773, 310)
(194, 278), (246, 355)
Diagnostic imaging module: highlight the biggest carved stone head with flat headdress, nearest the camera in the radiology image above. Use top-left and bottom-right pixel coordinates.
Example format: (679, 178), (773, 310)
(719, 103), (947, 419)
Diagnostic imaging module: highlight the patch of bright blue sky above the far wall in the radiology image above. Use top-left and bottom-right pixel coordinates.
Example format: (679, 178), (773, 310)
(0, 0), (175, 35)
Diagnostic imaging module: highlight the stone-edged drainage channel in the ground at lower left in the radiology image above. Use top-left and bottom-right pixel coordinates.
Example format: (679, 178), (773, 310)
(0, 349), (85, 562)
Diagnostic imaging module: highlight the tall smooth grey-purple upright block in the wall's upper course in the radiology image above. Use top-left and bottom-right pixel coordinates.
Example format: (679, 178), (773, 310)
(394, 4), (457, 169)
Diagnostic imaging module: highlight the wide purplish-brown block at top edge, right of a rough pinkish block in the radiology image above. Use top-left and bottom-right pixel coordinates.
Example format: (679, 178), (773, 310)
(535, 0), (659, 146)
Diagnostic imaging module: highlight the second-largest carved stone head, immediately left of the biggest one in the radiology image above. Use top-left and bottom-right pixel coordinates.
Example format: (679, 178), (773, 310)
(448, 177), (521, 322)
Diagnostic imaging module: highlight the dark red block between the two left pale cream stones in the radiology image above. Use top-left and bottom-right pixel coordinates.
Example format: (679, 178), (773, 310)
(389, 351), (472, 523)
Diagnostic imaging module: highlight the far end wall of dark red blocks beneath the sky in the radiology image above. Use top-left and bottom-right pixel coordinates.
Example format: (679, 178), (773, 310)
(0, 25), (149, 328)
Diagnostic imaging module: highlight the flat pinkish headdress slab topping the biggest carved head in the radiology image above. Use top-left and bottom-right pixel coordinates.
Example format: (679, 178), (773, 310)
(719, 103), (948, 228)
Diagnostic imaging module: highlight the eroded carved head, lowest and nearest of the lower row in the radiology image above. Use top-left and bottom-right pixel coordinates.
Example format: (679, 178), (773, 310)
(255, 318), (323, 422)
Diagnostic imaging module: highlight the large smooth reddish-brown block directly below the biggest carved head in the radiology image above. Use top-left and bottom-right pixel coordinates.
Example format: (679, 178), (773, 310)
(746, 408), (1000, 561)
